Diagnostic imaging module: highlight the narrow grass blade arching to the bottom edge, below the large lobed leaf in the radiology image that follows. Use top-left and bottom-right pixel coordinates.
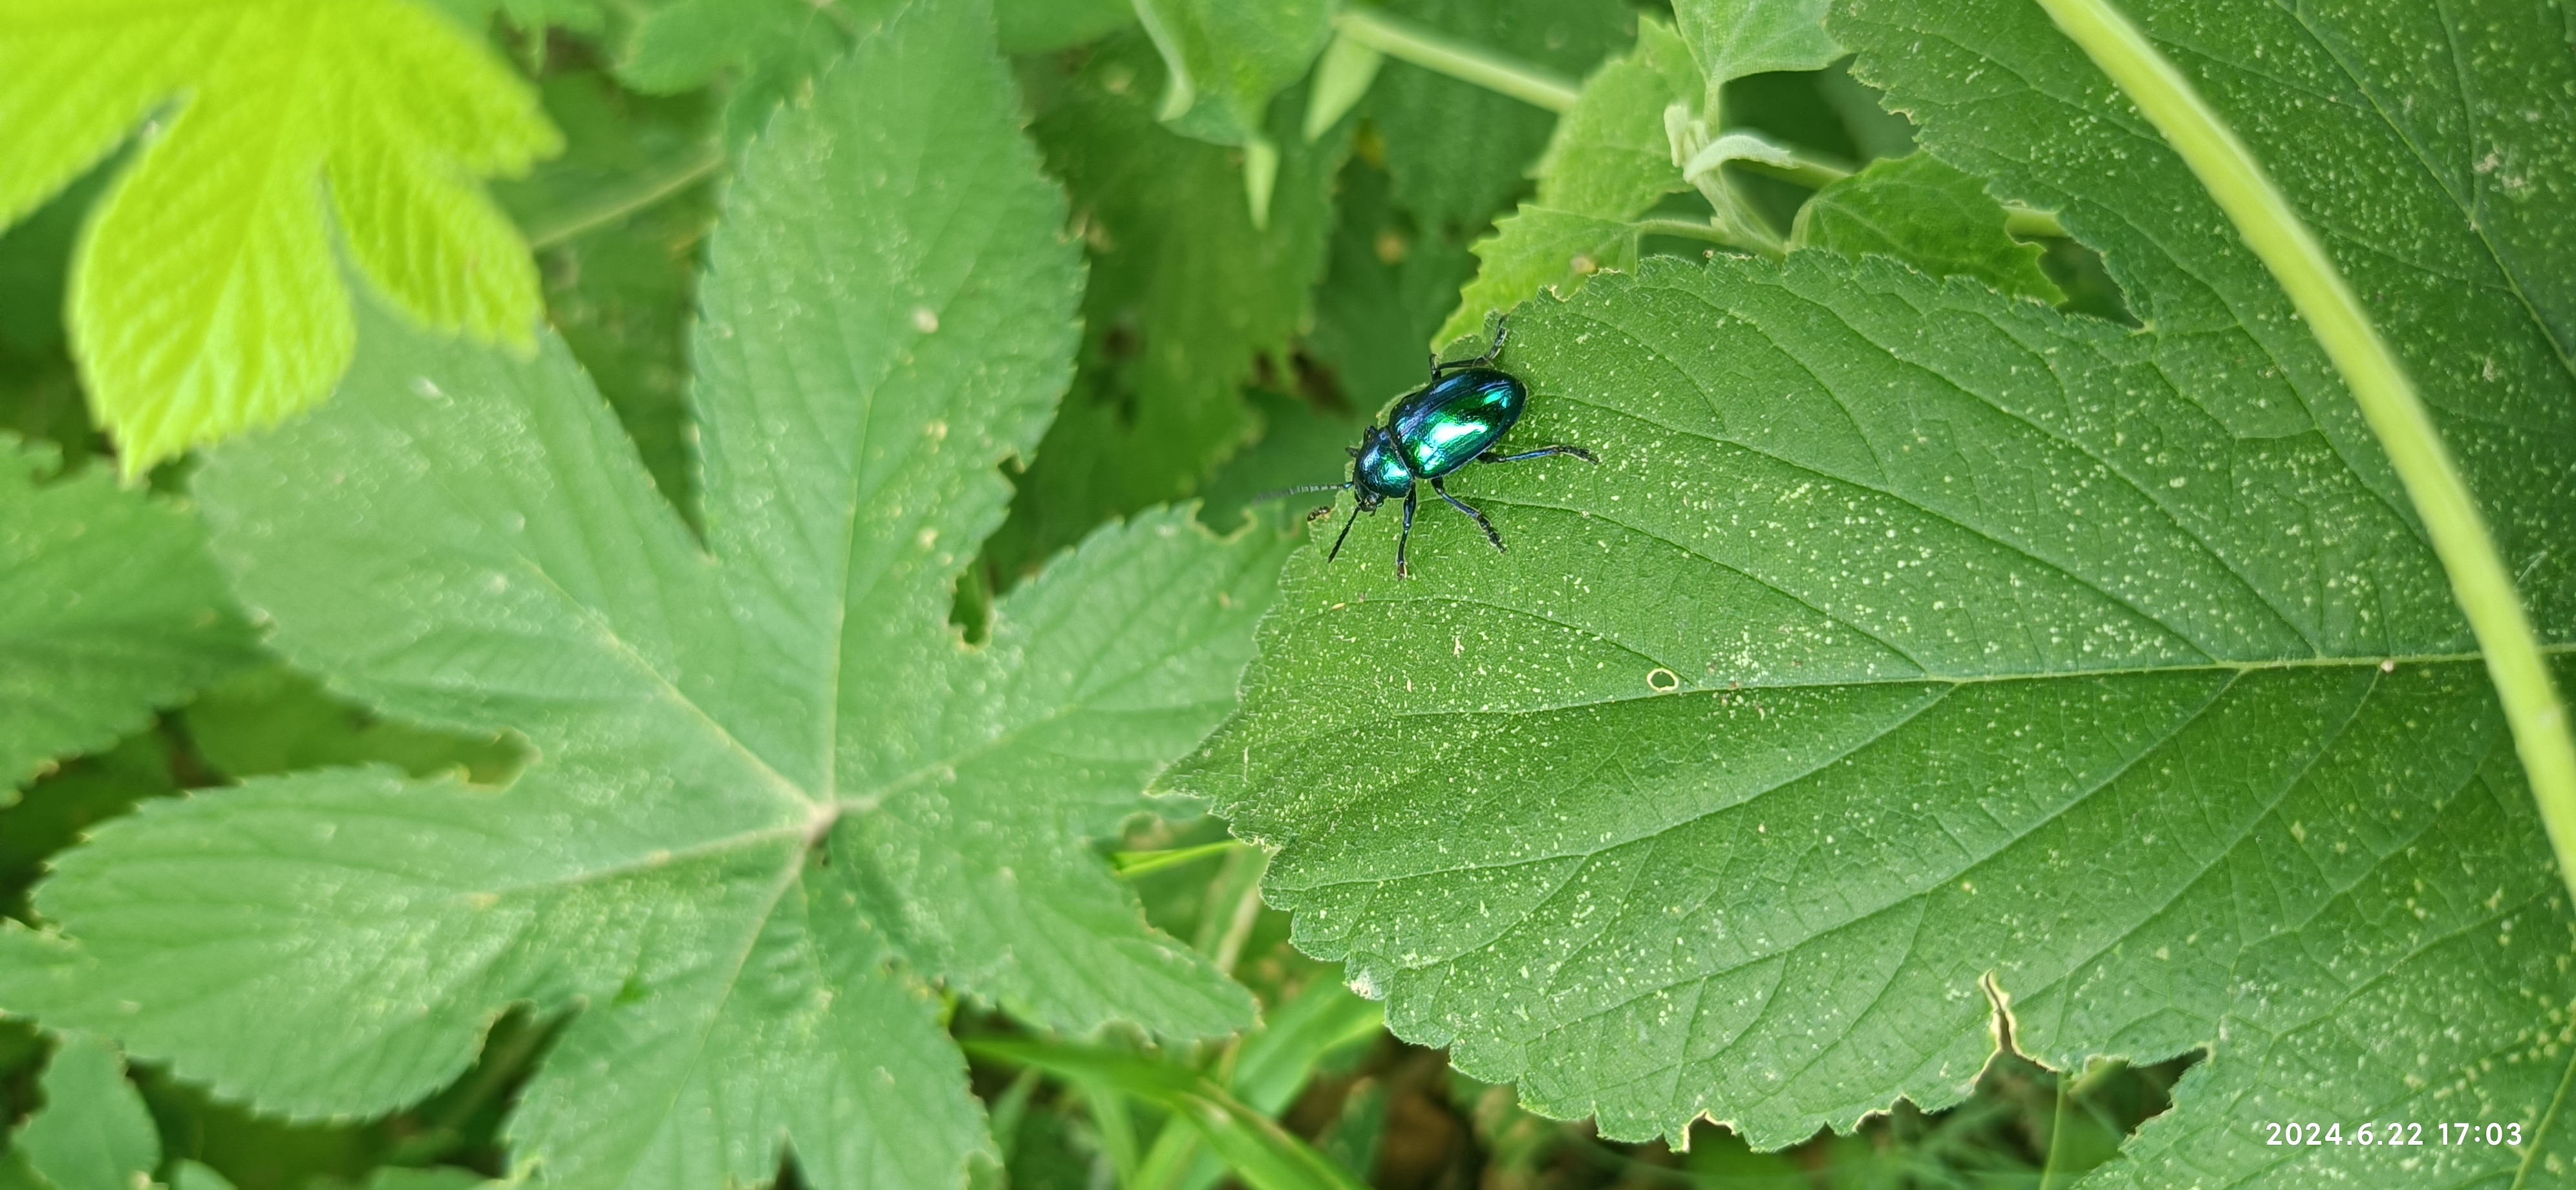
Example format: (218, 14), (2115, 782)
(966, 1041), (1360, 1190)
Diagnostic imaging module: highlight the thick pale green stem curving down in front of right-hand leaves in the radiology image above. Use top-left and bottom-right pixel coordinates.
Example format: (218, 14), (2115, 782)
(2037, 0), (2576, 891)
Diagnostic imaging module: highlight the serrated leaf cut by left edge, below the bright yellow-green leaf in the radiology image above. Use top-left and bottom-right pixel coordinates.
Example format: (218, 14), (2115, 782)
(0, 435), (252, 804)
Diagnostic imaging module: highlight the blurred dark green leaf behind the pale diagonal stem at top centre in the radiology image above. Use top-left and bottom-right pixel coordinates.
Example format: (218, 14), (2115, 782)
(1360, 0), (1638, 234)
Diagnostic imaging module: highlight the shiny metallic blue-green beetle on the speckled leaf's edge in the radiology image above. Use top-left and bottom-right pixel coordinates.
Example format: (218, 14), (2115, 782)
(1272, 317), (1600, 579)
